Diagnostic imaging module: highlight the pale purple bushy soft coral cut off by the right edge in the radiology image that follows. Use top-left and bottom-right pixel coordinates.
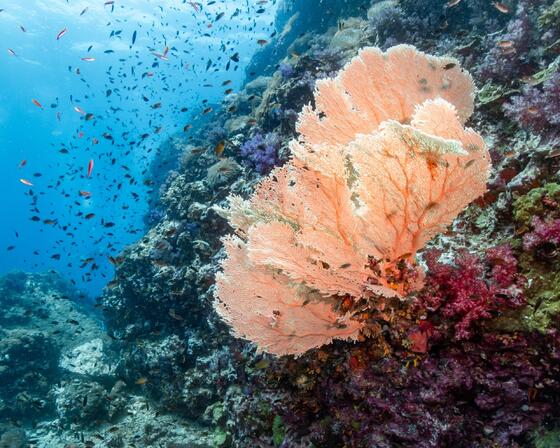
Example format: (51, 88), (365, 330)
(504, 72), (560, 131)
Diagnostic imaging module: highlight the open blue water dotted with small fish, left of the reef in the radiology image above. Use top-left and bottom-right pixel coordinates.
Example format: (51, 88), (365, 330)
(0, 0), (275, 295)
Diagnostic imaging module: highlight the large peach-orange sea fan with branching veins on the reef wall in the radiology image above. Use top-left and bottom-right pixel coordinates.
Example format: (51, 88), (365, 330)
(215, 45), (489, 355)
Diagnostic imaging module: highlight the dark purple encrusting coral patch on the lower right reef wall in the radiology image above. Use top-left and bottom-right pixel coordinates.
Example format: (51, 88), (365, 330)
(302, 335), (560, 448)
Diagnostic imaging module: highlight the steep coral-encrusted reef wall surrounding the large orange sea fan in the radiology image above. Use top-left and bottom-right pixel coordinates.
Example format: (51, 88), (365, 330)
(4, 0), (560, 448)
